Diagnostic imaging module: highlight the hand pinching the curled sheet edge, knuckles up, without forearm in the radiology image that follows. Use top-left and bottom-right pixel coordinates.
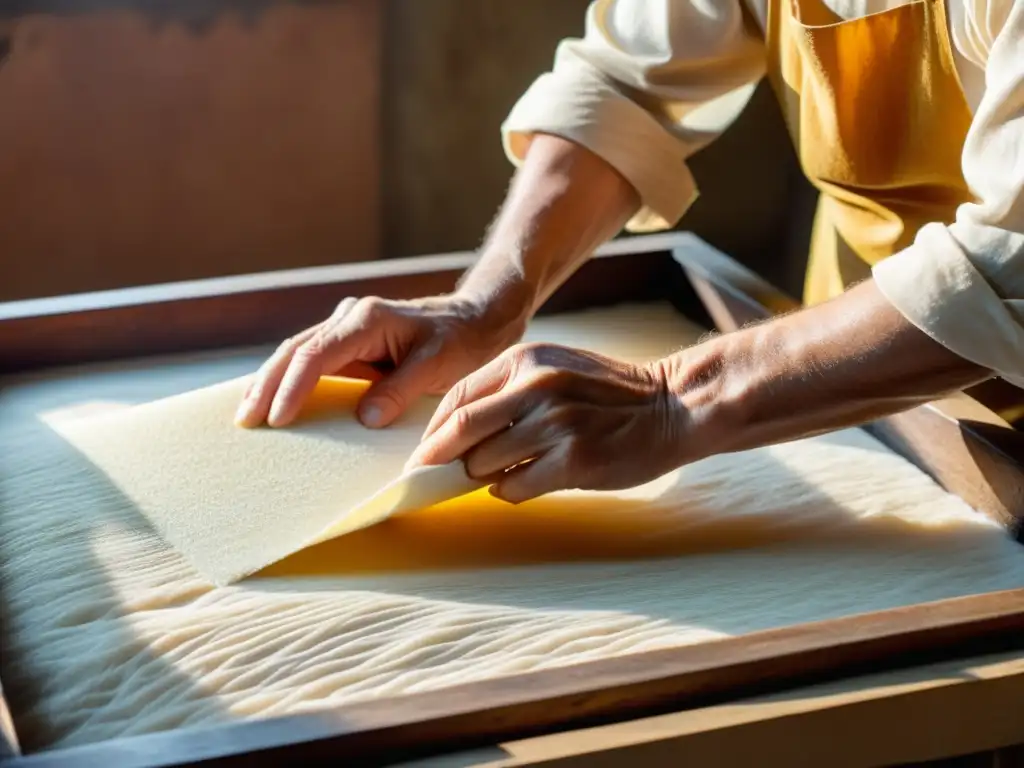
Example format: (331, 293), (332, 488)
(409, 344), (688, 503)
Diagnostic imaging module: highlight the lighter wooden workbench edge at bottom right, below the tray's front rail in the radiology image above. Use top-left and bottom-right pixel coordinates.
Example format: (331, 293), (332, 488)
(468, 650), (1024, 768)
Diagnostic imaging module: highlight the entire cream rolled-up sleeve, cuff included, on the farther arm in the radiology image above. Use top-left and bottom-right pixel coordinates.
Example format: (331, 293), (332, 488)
(502, 0), (764, 231)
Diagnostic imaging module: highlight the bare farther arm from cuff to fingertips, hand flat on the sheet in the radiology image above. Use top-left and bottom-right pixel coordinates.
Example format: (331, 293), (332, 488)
(237, 136), (638, 434)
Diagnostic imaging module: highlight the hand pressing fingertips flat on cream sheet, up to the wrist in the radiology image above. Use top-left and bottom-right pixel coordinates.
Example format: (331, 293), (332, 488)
(236, 296), (525, 427)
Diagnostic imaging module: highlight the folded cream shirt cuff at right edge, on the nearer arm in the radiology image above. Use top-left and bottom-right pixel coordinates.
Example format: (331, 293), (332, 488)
(871, 224), (1024, 387)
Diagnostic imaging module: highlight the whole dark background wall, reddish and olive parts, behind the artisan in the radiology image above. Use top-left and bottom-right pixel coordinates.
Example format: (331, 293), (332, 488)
(0, 0), (805, 300)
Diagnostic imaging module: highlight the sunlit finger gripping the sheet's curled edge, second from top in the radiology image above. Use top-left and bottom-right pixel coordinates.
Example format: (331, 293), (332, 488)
(407, 391), (522, 468)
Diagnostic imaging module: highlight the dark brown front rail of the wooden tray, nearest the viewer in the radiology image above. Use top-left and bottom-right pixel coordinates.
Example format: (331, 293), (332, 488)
(8, 589), (1024, 768)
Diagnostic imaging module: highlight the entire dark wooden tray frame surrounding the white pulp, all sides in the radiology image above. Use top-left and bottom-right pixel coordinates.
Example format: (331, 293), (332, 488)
(0, 233), (1024, 768)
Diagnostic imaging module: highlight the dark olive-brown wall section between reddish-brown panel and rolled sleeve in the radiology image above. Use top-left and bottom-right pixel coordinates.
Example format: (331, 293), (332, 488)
(383, 0), (589, 256)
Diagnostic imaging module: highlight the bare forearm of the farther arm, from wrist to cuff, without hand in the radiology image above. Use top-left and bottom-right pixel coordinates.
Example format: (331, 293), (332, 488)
(458, 135), (639, 323)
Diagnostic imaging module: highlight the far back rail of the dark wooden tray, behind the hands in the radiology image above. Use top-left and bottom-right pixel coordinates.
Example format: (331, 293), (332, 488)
(0, 232), (691, 374)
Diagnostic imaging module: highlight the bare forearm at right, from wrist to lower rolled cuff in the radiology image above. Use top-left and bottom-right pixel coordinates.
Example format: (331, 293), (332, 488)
(664, 281), (990, 453)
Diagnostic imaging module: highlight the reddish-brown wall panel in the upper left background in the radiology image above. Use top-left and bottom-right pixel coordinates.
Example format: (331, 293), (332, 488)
(0, 0), (381, 299)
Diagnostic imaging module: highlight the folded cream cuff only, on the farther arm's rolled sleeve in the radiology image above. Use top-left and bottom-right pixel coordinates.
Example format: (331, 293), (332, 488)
(502, 68), (697, 231)
